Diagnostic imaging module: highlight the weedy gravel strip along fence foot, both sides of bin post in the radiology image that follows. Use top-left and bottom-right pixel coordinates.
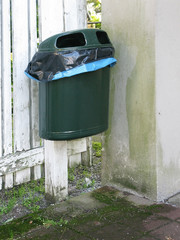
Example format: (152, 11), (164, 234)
(0, 142), (101, 225)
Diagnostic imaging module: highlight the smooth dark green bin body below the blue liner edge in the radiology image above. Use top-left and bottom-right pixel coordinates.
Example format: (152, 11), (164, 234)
(39, 67), (110, 140)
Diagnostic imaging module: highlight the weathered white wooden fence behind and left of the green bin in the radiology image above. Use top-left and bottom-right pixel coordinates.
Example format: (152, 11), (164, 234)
(0, 0), (87, 190)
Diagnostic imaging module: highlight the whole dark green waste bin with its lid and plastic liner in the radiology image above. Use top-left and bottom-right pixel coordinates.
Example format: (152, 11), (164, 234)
(26, 29), (116, 140)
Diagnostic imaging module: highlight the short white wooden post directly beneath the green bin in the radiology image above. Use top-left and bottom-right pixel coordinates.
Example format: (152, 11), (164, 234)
(45, 141), (68, 202)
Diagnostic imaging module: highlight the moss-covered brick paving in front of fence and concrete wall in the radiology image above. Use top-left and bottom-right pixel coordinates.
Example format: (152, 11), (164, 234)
(0, 186), (180, 240)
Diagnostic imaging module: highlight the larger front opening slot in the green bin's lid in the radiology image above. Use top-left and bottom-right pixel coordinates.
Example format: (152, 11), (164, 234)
(56, 33), (86, 48)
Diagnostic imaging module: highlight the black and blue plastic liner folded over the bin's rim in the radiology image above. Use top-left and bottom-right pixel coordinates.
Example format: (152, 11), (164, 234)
(25, 47), (116, 82)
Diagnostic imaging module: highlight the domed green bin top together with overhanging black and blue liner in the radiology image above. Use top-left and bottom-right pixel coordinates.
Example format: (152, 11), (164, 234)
(25, 29), (116, 82)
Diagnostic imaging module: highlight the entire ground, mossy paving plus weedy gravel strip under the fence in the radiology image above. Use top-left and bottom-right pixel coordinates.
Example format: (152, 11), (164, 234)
(0, 139), (180, 240)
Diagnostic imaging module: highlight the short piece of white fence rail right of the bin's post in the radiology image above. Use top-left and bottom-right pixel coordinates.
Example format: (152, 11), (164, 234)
(67, 138), (87, 156)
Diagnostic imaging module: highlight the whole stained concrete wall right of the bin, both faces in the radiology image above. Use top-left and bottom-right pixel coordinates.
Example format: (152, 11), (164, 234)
(102, 0), (180, 200)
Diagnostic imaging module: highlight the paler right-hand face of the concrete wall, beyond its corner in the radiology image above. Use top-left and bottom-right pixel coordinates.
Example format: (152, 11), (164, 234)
(155, 0), (180, 199)
